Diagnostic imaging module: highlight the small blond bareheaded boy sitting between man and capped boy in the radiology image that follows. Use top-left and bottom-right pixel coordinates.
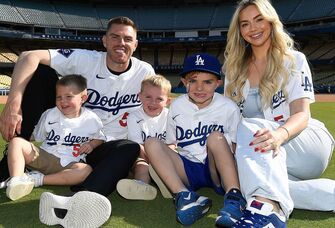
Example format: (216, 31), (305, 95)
(116, 75), (172, 200)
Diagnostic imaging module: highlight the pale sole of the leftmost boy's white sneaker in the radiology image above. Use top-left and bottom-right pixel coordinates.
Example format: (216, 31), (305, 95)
(6, 181), (34, 201)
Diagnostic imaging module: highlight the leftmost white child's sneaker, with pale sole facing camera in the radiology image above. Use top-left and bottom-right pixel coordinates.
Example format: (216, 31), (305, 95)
(6, 174), (34, 200)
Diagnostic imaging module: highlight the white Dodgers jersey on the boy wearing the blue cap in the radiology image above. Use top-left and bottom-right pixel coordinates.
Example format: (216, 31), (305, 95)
(166, 93), (240, 163)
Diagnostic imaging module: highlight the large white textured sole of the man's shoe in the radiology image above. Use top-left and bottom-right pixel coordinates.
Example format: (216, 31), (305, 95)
(39, 191), (112, 228)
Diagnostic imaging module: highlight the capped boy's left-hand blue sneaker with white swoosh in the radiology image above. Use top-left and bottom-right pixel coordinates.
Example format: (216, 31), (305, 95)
(175, 191), (212, 226)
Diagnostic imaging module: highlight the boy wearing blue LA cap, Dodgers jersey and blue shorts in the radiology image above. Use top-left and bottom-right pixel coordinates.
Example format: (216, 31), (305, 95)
(145, 54), (246, 226)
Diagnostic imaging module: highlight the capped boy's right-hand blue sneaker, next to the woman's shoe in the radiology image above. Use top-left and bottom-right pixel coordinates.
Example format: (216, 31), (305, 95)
(215, 188), (247, 227)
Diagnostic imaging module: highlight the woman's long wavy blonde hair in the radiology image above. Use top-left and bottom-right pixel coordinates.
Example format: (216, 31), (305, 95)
(223, 0), (294, 107)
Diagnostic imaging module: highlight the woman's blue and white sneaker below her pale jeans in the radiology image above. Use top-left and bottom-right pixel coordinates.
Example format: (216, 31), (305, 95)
(233, 199), (286, 228)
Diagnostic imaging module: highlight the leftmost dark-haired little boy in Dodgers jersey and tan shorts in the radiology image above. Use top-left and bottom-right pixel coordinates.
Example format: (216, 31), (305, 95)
(6, 75), (105, 200)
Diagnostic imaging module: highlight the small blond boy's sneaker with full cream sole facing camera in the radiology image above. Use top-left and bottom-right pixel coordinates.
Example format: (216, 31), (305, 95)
(116, 179), (157, 200)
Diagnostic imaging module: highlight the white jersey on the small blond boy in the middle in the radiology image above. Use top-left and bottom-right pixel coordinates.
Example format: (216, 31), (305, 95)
(127, 107), (169, 144)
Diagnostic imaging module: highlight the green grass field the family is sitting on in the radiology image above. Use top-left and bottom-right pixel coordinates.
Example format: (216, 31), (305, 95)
(0, 102), (335, 228)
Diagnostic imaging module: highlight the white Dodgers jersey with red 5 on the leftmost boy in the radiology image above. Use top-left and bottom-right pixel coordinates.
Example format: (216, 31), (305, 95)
(33, 107), (106, 166)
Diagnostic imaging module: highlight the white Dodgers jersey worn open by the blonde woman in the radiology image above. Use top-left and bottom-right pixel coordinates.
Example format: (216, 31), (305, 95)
(225, 51), (315, 122)
